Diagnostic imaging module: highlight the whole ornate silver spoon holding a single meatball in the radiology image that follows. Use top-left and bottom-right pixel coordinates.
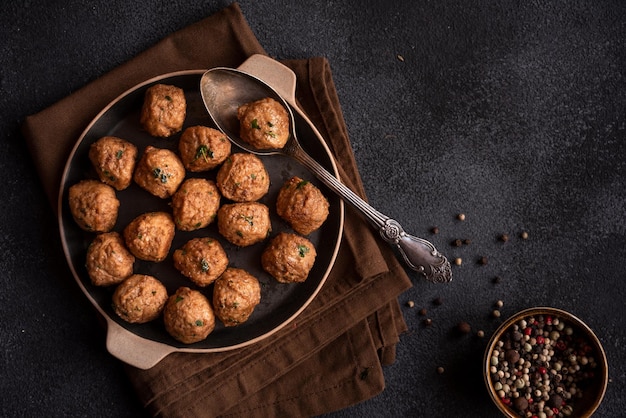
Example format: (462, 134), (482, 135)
(200, 67), (452, 283)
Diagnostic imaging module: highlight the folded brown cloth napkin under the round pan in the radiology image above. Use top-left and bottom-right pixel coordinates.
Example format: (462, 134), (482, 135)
(23, 3), (411, 417)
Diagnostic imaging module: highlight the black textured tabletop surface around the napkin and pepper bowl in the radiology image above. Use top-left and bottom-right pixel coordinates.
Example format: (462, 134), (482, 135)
(0, 0), (626, 417)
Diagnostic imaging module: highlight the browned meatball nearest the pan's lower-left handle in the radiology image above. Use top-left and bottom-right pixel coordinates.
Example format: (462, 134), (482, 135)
(113, 274), (167, 324)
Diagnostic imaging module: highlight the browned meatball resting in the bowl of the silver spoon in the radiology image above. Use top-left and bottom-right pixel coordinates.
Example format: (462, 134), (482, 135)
(237, 97), (289, 149)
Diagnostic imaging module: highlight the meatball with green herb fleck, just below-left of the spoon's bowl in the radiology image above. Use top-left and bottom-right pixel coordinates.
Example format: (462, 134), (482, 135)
(178, 126), (231, 172)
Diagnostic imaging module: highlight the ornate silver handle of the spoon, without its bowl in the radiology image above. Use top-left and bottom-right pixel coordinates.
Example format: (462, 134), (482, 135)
(283, 138), (452, 283)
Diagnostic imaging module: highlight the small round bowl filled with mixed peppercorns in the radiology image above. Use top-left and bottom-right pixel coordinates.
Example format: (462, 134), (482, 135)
(483, 307), (608, 418)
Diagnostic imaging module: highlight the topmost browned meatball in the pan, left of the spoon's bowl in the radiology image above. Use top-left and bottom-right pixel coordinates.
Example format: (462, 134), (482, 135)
(139, 84), (187, 138)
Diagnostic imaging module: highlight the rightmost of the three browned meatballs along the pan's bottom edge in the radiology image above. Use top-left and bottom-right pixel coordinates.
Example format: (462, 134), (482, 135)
(213, 267), (261, 327)
